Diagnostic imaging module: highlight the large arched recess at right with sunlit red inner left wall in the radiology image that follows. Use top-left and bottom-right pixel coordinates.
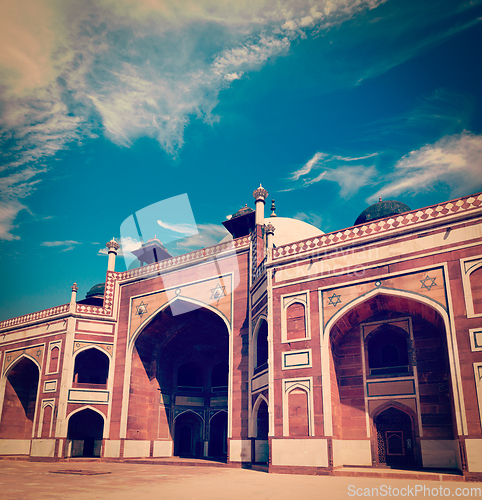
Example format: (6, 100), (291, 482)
(324, 291), (458, 468)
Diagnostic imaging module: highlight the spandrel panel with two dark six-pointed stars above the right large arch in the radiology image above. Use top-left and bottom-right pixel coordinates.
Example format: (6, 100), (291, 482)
(323, 268), (447, 327)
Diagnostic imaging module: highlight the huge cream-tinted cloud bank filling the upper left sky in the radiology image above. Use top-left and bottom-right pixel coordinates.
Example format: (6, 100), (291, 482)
(0, 0), (384, 239)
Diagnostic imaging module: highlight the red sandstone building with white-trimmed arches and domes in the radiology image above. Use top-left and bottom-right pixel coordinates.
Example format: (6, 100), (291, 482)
(0, 187), (482, 475)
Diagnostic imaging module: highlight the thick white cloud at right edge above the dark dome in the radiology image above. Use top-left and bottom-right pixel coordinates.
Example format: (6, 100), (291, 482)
(367, 132), (482, 201)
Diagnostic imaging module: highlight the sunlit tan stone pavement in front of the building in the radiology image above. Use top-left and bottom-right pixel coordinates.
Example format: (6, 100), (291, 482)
(0, 460), (482, 500)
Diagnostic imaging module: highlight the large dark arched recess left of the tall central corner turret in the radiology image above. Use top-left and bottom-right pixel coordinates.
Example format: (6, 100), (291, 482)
(127, 299), (229, 457)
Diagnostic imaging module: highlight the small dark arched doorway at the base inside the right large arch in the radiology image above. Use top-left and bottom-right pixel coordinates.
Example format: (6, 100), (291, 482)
(374, 407), (416, 468)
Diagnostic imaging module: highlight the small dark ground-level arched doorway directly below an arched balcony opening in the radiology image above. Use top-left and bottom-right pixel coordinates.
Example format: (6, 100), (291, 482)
(67, 408), (104, 457)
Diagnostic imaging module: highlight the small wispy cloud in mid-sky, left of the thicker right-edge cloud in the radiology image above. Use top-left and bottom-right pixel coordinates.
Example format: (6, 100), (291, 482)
(284, 152), (378, 198)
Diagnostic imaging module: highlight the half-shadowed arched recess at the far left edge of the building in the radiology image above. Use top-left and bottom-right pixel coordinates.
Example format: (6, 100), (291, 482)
(0, 357), (39, 439)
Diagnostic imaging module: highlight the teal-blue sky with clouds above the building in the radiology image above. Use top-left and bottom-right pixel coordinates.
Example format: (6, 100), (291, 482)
(0, 0), (482, 319)
